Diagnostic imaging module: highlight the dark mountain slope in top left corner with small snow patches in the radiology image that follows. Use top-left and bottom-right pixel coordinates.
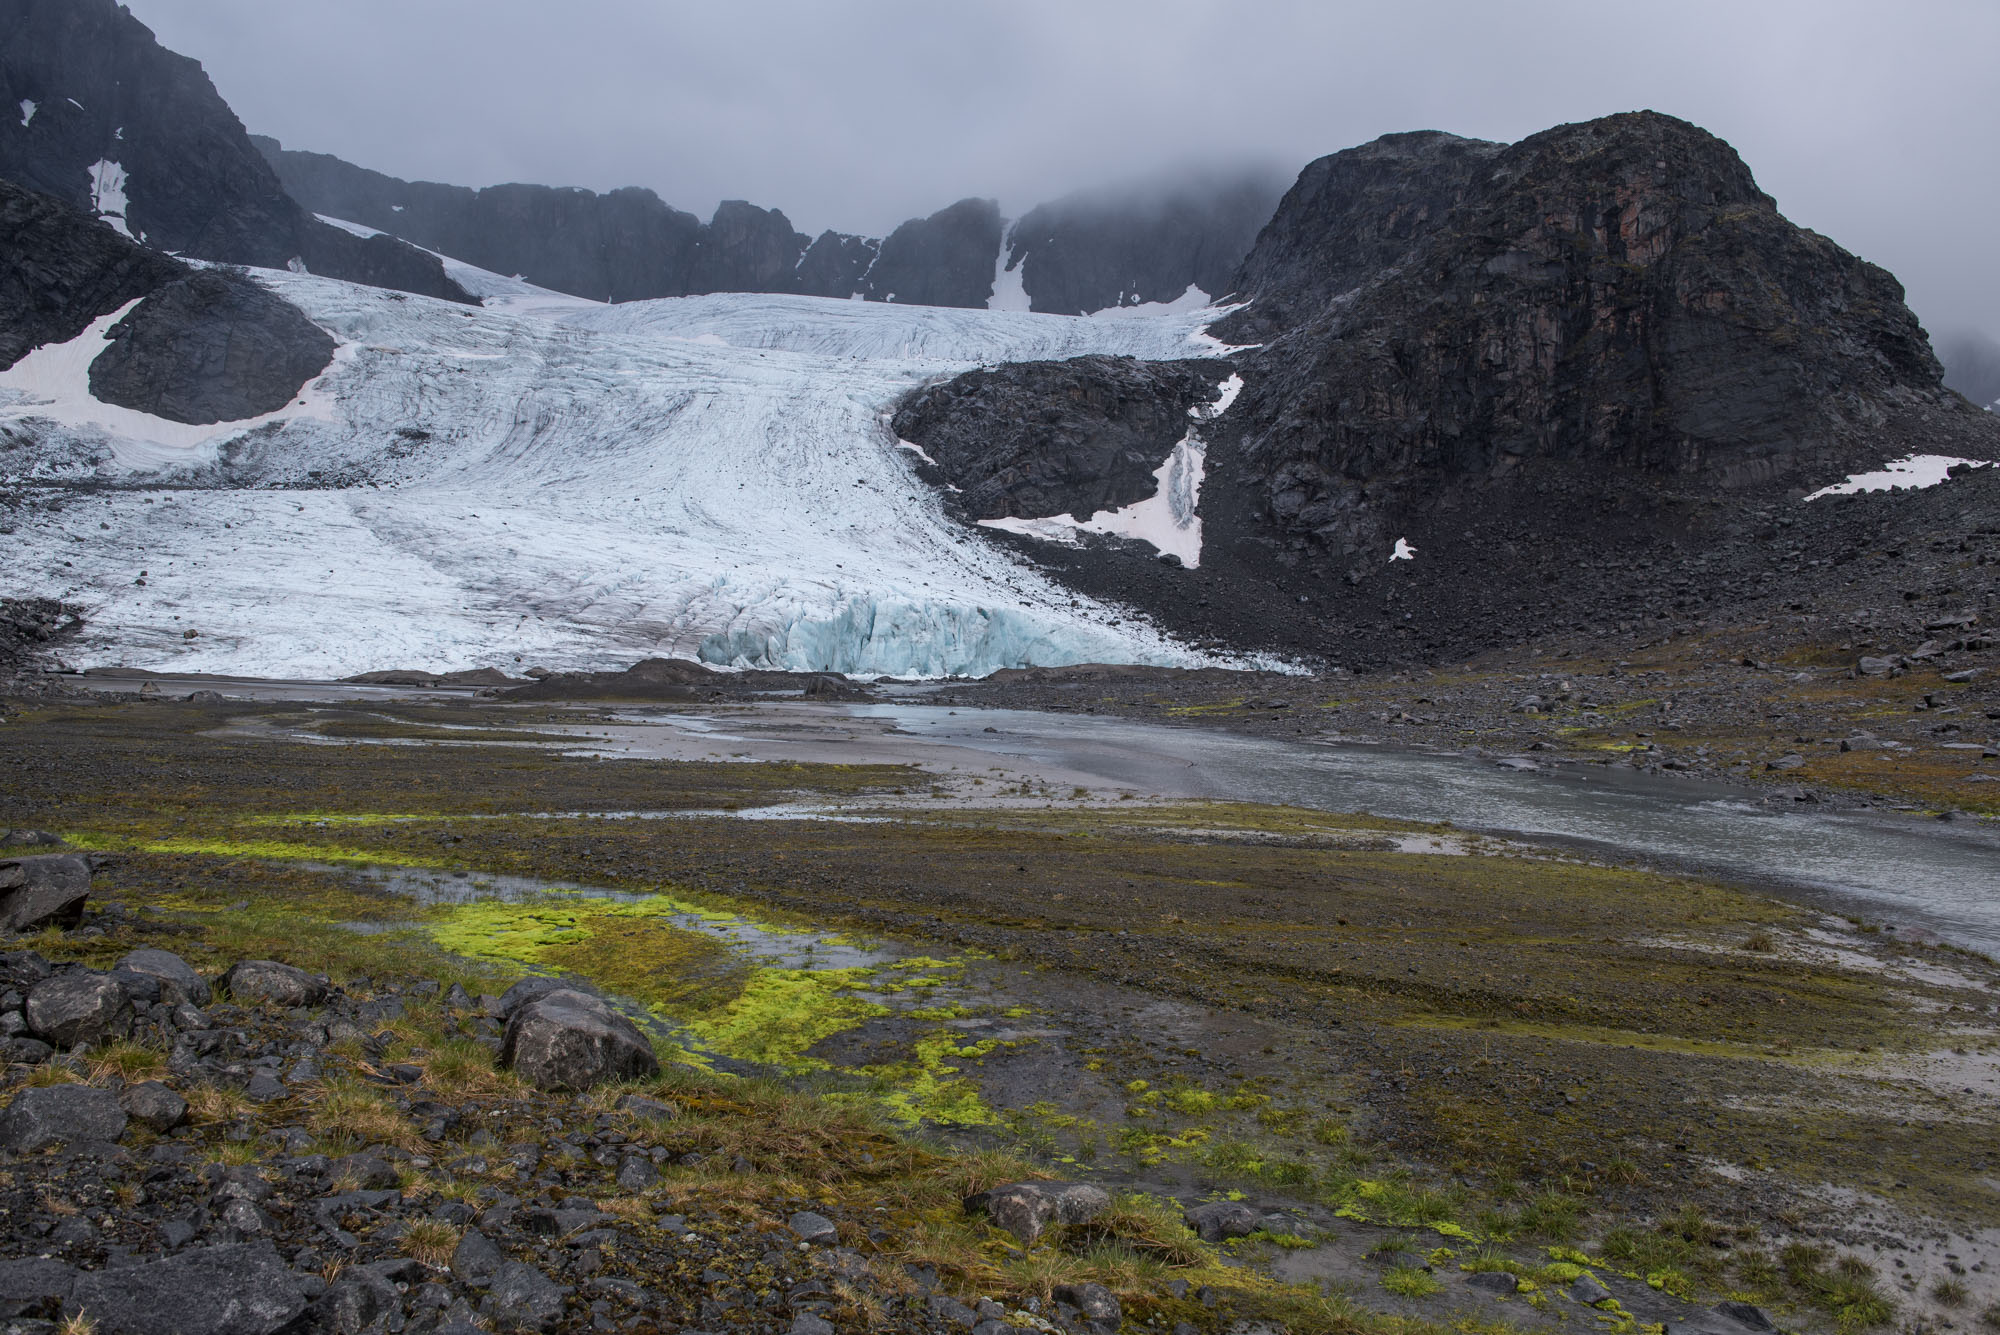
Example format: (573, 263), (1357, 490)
(0, 0), (470, 302)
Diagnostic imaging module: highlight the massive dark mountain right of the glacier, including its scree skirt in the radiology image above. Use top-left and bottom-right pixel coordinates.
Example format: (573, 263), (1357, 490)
(904, 112), (2000, 662)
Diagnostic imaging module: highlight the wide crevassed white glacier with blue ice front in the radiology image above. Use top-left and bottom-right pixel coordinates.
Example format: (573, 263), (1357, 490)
(0, 262), (1248, 677)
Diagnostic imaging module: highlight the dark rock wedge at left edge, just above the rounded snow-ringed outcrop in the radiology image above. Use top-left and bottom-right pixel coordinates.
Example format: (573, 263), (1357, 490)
(0, 174), (188, 370)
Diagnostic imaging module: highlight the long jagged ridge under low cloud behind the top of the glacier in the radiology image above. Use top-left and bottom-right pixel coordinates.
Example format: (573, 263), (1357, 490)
(252, 136), (1280, 316)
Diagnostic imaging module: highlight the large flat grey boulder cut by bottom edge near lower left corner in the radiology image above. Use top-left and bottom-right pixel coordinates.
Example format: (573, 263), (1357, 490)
(62, 1241), (306, 1335)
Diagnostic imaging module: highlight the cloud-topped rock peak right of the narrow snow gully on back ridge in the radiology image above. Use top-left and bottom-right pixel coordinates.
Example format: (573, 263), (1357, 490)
(1006, 163), (1286, 316)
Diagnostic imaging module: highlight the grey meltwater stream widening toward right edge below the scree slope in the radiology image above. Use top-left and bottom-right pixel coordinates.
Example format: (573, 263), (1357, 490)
(856, 703), (2000, 955)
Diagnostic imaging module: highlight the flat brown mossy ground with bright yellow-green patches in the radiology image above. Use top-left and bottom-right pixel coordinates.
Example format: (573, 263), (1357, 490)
(0, 705), (2000, 1329)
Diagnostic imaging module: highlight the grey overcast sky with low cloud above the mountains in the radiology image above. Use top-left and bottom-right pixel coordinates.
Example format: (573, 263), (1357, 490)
(128, 0), (2000, 336)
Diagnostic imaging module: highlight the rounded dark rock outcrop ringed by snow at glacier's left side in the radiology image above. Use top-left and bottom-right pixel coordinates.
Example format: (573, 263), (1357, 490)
(90, 270), (334, 422)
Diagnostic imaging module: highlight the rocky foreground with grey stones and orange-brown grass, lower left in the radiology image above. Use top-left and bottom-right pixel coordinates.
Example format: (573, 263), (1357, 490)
(0, 853), (1160, 1335)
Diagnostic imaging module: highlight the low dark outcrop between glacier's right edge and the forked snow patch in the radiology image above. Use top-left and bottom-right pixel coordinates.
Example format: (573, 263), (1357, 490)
(894, 358), (1230, 520)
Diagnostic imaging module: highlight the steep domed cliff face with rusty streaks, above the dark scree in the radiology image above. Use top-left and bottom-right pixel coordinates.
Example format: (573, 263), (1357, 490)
(1228, 114), (1968, 563)
